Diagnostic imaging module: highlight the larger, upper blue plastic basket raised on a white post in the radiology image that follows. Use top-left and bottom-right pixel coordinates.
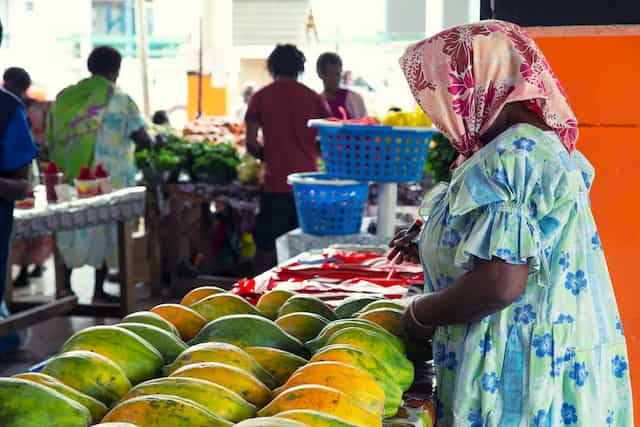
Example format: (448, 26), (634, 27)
(309, 120), (437, 182)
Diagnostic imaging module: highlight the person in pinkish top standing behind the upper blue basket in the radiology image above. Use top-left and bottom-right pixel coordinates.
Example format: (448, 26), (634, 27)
(316, 52), (367, 119)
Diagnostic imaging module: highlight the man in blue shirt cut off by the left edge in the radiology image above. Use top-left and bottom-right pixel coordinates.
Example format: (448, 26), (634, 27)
(0, 19), (38, 352)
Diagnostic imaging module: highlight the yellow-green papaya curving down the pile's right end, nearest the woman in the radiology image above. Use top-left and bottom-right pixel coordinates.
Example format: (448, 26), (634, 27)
(327, 328), (414, 390)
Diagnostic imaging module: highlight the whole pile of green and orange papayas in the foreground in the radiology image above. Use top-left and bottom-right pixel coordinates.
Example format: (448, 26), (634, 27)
(0, 286), (431, 427)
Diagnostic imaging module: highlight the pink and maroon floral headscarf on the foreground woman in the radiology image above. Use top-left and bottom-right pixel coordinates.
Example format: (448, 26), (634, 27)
(400, 21), (578, 164)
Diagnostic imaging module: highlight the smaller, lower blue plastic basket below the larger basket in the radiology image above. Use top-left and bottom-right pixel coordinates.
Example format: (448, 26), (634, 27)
(288, 172), (369, 235)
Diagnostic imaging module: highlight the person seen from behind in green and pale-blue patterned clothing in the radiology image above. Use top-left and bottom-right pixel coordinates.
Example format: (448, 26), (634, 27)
(49, 46), (152, 301)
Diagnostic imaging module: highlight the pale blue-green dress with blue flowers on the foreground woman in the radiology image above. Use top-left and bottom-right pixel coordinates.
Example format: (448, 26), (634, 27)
(420, 125), (633, 427)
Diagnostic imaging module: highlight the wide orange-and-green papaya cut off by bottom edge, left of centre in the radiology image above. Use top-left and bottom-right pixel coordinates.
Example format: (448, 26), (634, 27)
(102, 394), (233, 427)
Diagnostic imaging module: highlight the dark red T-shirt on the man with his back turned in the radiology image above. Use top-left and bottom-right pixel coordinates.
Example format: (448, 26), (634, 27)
(245, 80), (331, 193)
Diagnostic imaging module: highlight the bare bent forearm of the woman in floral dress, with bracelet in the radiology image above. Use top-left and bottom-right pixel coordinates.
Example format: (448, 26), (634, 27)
(405, 258), (529, 339)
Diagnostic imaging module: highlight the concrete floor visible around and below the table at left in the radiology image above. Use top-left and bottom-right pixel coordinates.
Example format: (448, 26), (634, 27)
(0, 260), (175, 376)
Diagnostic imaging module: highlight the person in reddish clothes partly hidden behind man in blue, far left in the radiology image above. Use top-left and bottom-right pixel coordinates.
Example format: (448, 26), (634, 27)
(2, 67), (52, 288)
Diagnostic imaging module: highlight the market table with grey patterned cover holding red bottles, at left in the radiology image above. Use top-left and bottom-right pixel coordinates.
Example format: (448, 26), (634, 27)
(0, 187), (146, 336)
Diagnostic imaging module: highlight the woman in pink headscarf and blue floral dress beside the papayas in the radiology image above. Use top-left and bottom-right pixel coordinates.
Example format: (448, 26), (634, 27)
(391, 21), (633, 427)
